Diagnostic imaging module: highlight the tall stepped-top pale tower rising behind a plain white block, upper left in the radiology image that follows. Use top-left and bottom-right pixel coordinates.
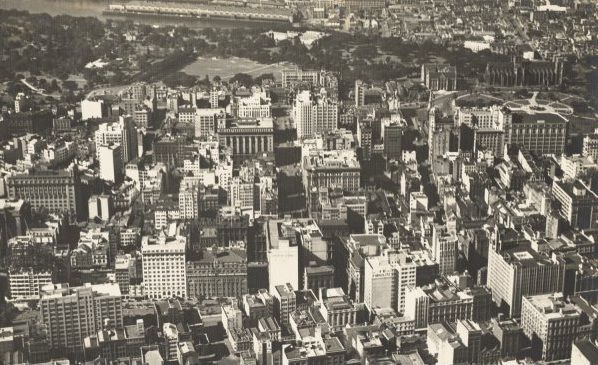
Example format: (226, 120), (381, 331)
(94, 117), (138, 164)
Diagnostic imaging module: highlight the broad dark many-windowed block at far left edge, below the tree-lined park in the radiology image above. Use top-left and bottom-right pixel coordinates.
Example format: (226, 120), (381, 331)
(6, 168), (84, 214)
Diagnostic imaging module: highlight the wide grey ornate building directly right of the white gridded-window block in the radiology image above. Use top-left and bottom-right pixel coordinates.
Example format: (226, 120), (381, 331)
(187, 248), (247, 298)
